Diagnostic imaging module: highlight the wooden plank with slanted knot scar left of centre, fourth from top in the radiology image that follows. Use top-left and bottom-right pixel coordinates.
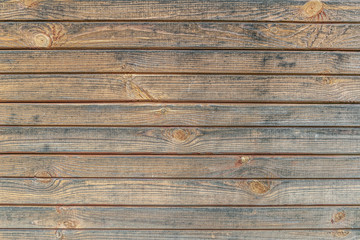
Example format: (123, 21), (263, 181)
(0, 74), (360, 102)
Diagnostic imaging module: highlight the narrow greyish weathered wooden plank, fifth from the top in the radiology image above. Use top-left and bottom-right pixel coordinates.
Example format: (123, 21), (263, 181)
(0, 103), (360, 126)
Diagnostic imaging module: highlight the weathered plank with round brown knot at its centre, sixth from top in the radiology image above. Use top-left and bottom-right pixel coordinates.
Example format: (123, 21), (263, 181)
(0, 127), (360, 154)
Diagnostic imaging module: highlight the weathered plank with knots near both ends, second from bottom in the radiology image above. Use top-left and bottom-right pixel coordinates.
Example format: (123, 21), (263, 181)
(0, 206), (360, 228)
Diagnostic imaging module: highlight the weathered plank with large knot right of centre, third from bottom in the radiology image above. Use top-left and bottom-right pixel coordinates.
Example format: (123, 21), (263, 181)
(0, 178), (360, 204)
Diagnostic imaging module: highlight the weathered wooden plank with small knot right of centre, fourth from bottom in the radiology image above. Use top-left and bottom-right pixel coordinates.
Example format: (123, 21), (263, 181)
(0, 155), (360, 178)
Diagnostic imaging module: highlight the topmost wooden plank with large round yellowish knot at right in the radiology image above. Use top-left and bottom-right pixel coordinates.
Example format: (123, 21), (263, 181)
(0, 0), (360, 22)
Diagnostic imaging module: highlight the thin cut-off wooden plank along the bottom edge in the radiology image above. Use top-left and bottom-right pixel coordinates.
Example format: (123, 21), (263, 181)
(0, 229), (360, 240)
